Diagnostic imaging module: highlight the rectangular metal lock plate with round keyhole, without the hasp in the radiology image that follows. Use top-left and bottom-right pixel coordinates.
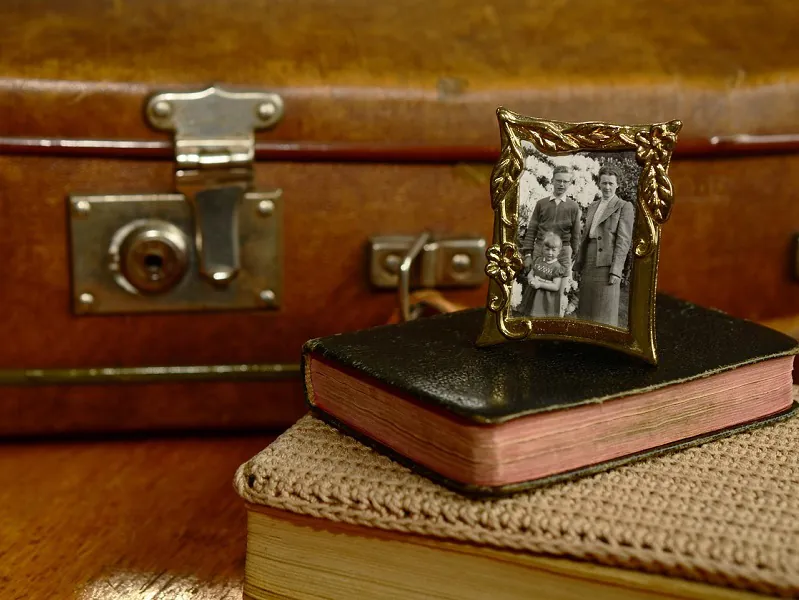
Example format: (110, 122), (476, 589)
(69, 190), (283, 314)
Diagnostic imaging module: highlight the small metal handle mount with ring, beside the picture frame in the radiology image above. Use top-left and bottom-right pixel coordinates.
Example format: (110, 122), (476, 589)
(369, 231), (486, 321)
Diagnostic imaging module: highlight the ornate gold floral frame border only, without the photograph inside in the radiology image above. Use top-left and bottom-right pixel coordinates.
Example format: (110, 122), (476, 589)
(477, 108), (682, 364)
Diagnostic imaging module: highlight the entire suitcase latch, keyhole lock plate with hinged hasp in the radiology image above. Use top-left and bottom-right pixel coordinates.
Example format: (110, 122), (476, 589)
(68, 87), (283, 314)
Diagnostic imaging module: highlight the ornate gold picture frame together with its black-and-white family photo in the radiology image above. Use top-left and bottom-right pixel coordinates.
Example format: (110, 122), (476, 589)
(477, 108), (682, 364)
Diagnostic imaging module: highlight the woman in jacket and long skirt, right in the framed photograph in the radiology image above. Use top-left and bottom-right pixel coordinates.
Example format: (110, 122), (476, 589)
(574, 165), (635, 328)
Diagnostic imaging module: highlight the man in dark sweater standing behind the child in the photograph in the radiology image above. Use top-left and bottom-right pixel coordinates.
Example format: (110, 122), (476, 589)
(521, 166), (580, 273)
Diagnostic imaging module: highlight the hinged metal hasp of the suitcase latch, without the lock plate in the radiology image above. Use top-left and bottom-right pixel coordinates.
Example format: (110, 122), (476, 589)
(145, 86), (283, 286)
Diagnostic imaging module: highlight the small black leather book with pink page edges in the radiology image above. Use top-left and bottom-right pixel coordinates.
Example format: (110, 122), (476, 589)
(303, 296), (799, 494)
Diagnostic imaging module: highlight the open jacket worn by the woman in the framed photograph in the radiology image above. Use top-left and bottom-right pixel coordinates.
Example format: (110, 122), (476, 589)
(575, 196), (635, 277)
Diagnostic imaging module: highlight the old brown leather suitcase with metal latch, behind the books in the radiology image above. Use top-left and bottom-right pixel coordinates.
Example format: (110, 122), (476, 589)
(0, 0), (799, 436)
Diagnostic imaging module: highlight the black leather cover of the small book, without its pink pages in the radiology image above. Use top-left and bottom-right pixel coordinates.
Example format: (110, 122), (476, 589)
(303, 294), (799, 495)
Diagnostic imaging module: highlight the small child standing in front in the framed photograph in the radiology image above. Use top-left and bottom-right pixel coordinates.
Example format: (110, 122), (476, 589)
(522, 231), (566, 317)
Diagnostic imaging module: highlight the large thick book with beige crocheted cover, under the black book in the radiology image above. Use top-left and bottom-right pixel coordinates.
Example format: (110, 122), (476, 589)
(235, 415), (799, 600)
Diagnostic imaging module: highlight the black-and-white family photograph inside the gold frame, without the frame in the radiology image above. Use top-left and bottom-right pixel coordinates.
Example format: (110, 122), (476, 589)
(510, 142), (641, 330)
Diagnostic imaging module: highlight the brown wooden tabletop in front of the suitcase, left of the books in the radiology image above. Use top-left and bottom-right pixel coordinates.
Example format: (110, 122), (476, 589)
(0, 436), (273, 600)
